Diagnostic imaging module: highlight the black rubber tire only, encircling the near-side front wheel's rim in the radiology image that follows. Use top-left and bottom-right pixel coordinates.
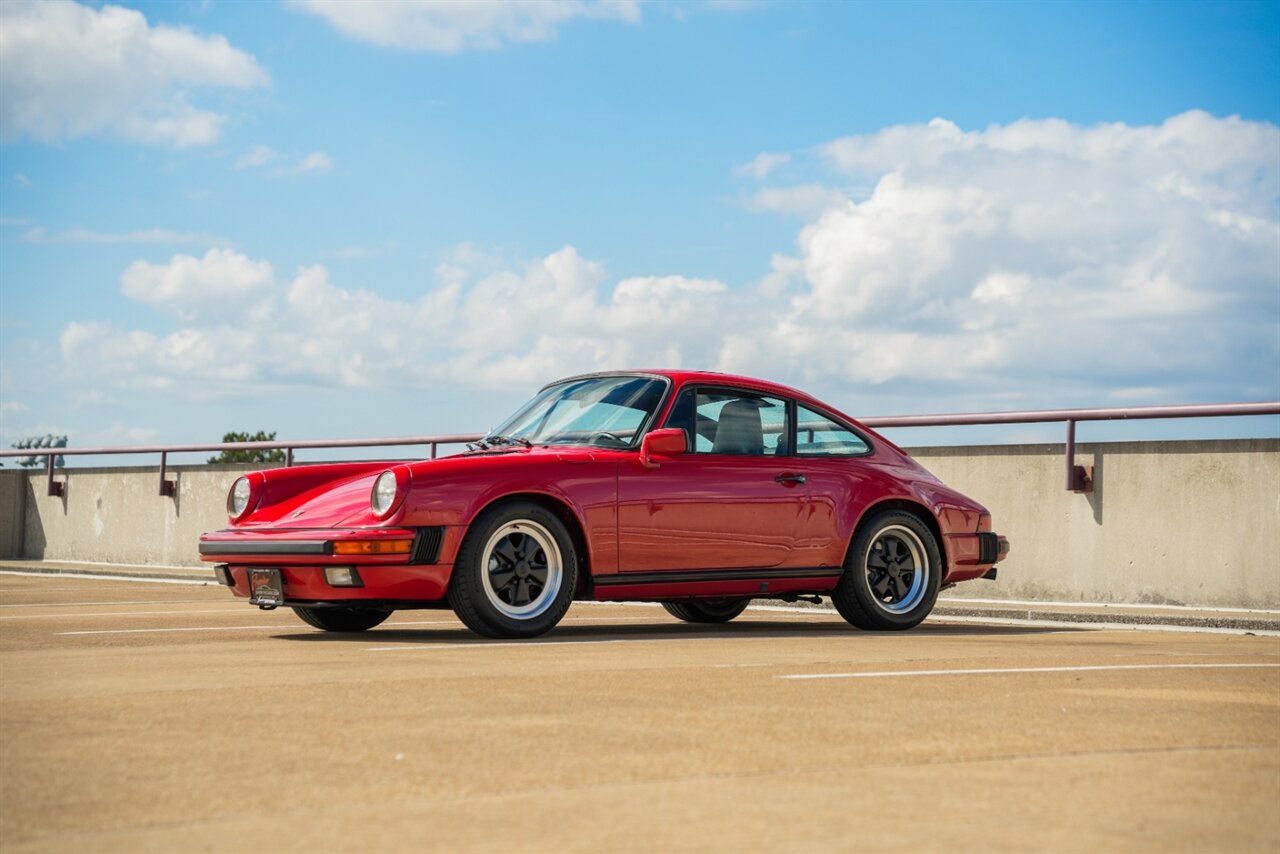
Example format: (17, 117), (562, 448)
(448, 502), (579, 638)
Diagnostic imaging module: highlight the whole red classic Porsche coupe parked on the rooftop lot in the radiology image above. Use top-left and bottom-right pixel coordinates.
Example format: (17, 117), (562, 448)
(200, 370), (1009, 638)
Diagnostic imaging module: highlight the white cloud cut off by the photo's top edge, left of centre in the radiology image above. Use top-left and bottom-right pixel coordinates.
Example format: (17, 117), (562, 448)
(291, 0), (640, 54)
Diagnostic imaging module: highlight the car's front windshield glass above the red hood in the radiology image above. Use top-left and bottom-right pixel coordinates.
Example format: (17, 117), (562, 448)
(484, 376), (666, 448)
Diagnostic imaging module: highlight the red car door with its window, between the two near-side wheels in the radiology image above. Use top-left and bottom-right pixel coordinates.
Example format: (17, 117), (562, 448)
(618, 387), (805, 572)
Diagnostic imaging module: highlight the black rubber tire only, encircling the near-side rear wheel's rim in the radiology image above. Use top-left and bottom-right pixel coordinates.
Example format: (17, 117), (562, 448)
(833, 511), (943, 630)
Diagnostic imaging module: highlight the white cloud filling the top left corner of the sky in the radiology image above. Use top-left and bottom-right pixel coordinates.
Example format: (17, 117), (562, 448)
(0, 0), (268, 149)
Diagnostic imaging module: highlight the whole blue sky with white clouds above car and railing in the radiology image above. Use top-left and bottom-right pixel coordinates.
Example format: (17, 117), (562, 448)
(0, 0), (1280, 458)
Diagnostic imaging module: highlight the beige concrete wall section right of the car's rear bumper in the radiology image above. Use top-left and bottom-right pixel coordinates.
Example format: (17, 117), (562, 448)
(913, 439), (1280, 608)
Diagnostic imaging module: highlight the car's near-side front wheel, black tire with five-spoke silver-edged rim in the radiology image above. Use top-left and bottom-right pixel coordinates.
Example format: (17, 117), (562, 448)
(448, 502), (577, 638)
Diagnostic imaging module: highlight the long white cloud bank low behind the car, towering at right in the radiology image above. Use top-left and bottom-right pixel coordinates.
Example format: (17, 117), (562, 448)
(49, 114), (1280, 412)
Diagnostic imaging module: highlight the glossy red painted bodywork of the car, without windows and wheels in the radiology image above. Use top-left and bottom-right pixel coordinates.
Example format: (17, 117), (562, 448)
(201, 371), (992, 604)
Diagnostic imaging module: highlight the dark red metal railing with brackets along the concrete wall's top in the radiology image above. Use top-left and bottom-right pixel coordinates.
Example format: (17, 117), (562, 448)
(0, 401), (1280, 498)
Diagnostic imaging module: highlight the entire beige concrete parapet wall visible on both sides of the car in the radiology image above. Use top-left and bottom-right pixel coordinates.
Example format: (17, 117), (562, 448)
(0, 439), (1280, 608)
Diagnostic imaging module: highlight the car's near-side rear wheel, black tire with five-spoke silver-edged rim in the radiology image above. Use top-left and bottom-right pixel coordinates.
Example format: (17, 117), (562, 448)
(831, 510), (942, 631)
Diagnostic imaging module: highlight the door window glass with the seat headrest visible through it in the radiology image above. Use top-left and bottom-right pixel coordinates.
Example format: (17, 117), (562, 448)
(667, 388), (787, 456)
